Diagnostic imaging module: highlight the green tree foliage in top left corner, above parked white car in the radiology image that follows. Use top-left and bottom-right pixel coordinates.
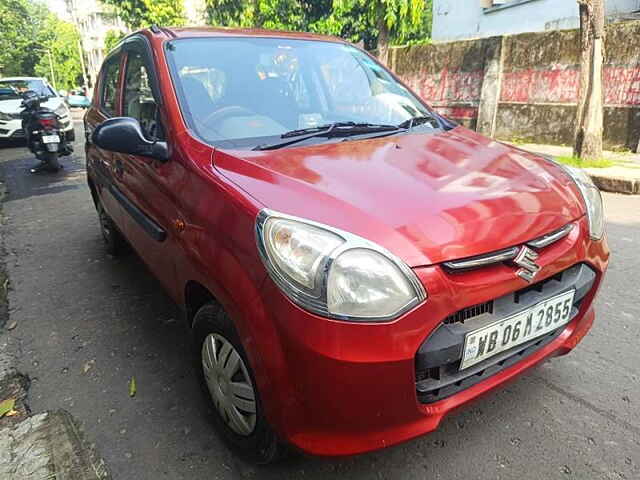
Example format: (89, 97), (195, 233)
(0, 0), (82, 89)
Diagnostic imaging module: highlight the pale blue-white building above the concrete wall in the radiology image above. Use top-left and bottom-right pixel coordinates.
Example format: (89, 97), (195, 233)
(433, 0), (640, 42)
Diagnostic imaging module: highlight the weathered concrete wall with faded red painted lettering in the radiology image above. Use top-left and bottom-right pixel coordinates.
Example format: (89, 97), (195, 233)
(391, 21), (640, 148)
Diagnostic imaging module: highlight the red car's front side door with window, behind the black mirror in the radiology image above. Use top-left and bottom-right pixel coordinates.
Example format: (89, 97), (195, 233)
(114, 37), (183, 293)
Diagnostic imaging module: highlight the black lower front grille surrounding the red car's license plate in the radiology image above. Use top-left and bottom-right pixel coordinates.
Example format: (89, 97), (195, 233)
(415, 264), (596, 403)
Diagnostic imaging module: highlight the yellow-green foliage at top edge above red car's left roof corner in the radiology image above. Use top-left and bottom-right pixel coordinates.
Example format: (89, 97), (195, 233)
(101, 0), (186, 30)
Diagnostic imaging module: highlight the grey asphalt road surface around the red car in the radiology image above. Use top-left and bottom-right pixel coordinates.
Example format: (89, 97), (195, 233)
(0, 119), (640, 480)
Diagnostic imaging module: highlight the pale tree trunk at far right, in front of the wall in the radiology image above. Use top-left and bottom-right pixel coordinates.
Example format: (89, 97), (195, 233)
(573, 0), (604, 158)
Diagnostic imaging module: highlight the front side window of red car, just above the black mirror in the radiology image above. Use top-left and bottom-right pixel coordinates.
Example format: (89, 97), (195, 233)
(122, 52), (164, 140)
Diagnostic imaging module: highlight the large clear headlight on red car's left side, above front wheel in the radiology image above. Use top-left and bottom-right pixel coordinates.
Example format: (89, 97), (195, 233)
(256, 210), (426, 322)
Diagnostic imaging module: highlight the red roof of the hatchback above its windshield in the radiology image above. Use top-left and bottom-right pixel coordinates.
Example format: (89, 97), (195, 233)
(145, 26), (348, 43)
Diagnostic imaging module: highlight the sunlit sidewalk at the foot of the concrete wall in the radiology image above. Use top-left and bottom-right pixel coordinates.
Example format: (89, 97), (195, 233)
(517, 143), (640, 195)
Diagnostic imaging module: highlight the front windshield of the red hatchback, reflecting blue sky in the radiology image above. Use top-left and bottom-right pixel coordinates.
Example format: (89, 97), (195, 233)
(167, 37), (431, 148)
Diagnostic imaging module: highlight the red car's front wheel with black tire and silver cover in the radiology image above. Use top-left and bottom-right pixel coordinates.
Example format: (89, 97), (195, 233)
(193, 303), (284, 465)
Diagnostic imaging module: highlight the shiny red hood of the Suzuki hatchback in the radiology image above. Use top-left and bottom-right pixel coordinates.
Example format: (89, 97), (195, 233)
(213, 127), (584, 267)
